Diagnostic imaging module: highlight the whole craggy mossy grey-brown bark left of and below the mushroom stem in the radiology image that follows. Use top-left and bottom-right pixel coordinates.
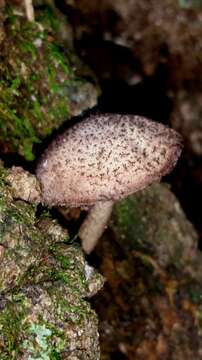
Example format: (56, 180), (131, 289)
(0, 164), (103, 360)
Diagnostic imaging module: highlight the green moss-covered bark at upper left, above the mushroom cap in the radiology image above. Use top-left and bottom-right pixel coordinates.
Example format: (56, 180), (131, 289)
(0, 11), (98, 160)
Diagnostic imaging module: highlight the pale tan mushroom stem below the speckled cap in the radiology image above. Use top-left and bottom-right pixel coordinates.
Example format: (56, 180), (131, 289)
(79, 201), (114, 254)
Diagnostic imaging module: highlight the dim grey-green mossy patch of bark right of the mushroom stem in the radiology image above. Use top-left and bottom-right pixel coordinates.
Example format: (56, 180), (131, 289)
(110, 184), (197, 270)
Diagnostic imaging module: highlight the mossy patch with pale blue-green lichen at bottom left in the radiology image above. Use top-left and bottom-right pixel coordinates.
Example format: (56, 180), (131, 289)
(0, 286), (91, 360)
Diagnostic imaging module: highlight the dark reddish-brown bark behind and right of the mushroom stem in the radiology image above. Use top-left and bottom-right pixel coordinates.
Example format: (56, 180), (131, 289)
(91, 184), (202, 360)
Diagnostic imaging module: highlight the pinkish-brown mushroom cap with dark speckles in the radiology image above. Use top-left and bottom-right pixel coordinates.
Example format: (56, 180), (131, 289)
(36, 114), (182, 207)
